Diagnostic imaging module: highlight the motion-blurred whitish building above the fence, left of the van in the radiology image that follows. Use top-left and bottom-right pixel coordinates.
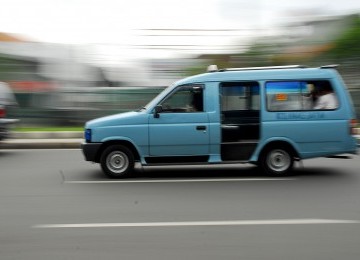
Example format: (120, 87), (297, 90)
(0, 33), (187, 91)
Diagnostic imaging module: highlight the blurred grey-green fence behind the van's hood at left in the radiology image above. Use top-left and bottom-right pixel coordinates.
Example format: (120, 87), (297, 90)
(8, 87), (164, 126)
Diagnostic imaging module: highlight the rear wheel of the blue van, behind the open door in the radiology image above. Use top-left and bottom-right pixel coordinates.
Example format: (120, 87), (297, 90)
(259, 146), (294, 177)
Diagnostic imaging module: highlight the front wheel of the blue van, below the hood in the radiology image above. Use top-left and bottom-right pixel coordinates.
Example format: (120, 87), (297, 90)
(100, 145), (135, 178)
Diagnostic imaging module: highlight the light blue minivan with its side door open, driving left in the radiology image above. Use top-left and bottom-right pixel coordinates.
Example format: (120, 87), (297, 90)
(82, 65), (357, 178)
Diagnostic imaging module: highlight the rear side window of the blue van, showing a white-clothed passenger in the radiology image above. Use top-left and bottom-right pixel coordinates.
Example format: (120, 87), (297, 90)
(265, 80), (339, 111)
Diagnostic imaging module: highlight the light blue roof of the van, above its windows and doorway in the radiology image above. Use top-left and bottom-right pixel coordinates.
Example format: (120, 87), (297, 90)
(176, 65), (337, 85)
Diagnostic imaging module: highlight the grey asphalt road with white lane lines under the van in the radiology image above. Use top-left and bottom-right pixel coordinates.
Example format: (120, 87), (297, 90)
(0, 150), (360, 260)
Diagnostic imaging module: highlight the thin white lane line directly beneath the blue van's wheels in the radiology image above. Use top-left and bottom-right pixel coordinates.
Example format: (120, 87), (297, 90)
(64, 178), (296, 184)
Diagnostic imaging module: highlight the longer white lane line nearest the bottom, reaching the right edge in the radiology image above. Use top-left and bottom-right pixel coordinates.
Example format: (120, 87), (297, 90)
(33, 219), (360, 228)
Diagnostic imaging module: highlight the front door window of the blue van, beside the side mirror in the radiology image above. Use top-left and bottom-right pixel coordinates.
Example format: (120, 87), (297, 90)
(160, 85), (204, 113)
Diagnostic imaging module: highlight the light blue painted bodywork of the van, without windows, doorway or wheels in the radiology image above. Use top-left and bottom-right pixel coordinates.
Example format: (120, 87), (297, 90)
(85, 68), (357, 164)
